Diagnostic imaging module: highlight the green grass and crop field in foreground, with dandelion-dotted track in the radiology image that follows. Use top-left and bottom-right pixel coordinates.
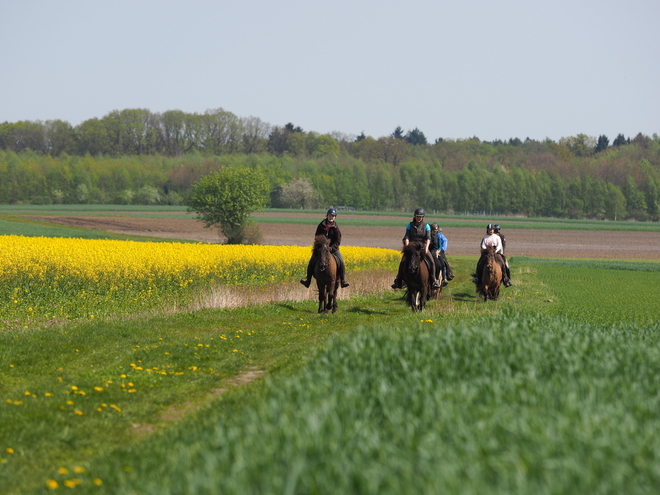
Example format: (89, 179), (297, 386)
(0, 207), (660, 494)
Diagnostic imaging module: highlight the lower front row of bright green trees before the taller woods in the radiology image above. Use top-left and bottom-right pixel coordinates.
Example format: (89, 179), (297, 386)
(0, 140), (660, 221)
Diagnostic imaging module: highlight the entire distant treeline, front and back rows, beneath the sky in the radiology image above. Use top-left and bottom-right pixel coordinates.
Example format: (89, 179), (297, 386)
(0, 109), (660, 221)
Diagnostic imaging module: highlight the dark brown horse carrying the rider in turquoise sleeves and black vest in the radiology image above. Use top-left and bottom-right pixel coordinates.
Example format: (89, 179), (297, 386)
(402, 242), (441, 313)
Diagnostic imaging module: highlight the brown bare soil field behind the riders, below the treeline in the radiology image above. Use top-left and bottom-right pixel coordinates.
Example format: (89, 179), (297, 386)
(27, 213), (660, 260)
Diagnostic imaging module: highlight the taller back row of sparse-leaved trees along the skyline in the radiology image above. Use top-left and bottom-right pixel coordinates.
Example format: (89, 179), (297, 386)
(0, 108), (655, 161)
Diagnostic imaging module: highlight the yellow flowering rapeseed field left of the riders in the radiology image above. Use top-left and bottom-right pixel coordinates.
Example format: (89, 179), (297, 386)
(0, 236), (400, 321)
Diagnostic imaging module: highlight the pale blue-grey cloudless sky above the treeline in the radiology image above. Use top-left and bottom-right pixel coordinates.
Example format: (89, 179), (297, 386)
(0, 0), (660, 143)
